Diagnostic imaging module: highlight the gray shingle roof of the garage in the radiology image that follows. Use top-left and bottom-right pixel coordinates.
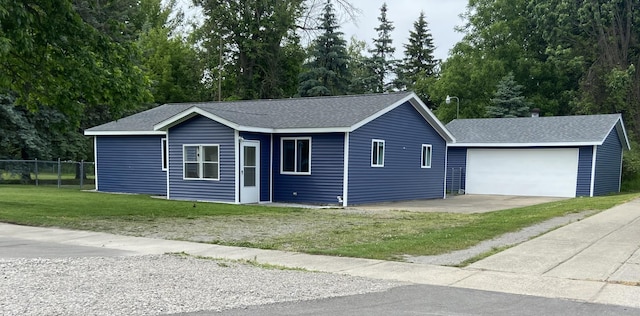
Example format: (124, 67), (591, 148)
(446, 114), (626, 145)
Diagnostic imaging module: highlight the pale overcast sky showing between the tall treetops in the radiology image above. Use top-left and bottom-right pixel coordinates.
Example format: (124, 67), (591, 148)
(341, 0), (468, 60)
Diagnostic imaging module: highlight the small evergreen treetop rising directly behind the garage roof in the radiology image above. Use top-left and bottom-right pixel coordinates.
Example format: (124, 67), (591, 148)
(487, 72), (529, 117)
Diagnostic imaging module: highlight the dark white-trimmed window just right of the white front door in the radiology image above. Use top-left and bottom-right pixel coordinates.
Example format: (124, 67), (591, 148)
(280, 137), (311, 174)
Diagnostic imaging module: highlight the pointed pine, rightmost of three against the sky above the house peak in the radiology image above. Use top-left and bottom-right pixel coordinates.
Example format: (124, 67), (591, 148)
(396, 11), (438, 89)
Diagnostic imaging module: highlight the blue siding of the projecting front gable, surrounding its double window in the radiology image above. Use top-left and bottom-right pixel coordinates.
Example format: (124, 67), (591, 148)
(168, 116), (235, 202)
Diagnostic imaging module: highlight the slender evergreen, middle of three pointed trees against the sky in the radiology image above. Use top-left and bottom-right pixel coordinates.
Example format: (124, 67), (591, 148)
(368, 2), (397, 93)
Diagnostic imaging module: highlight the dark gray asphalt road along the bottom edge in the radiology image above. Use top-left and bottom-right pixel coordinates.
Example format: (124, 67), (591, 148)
(177, 285), (640, 316)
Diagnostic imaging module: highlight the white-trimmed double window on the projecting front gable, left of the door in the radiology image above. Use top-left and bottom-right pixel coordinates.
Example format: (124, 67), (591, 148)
(182, 145), (220, 180)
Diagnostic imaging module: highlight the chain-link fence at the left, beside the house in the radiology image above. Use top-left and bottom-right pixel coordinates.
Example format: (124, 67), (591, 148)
(0, 159), (95, 190)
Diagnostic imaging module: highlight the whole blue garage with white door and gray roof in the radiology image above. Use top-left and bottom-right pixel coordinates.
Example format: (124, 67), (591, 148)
(445, 114), (629, 197)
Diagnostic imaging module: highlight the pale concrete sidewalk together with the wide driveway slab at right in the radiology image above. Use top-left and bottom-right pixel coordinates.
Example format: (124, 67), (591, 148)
(0, 200), (640, 308)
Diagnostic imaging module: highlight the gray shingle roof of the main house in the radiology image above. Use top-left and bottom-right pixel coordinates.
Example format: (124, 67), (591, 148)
(86, 92), (412, 134)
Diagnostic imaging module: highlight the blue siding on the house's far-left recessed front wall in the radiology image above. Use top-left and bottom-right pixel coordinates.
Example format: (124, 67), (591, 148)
(96, 135), (167, 195)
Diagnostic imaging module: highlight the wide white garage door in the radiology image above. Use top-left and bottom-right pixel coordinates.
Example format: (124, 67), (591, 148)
(465, 148), (578, 197)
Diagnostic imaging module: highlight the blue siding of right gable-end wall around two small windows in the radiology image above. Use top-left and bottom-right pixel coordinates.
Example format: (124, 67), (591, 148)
(348, 102), (446, 204)
